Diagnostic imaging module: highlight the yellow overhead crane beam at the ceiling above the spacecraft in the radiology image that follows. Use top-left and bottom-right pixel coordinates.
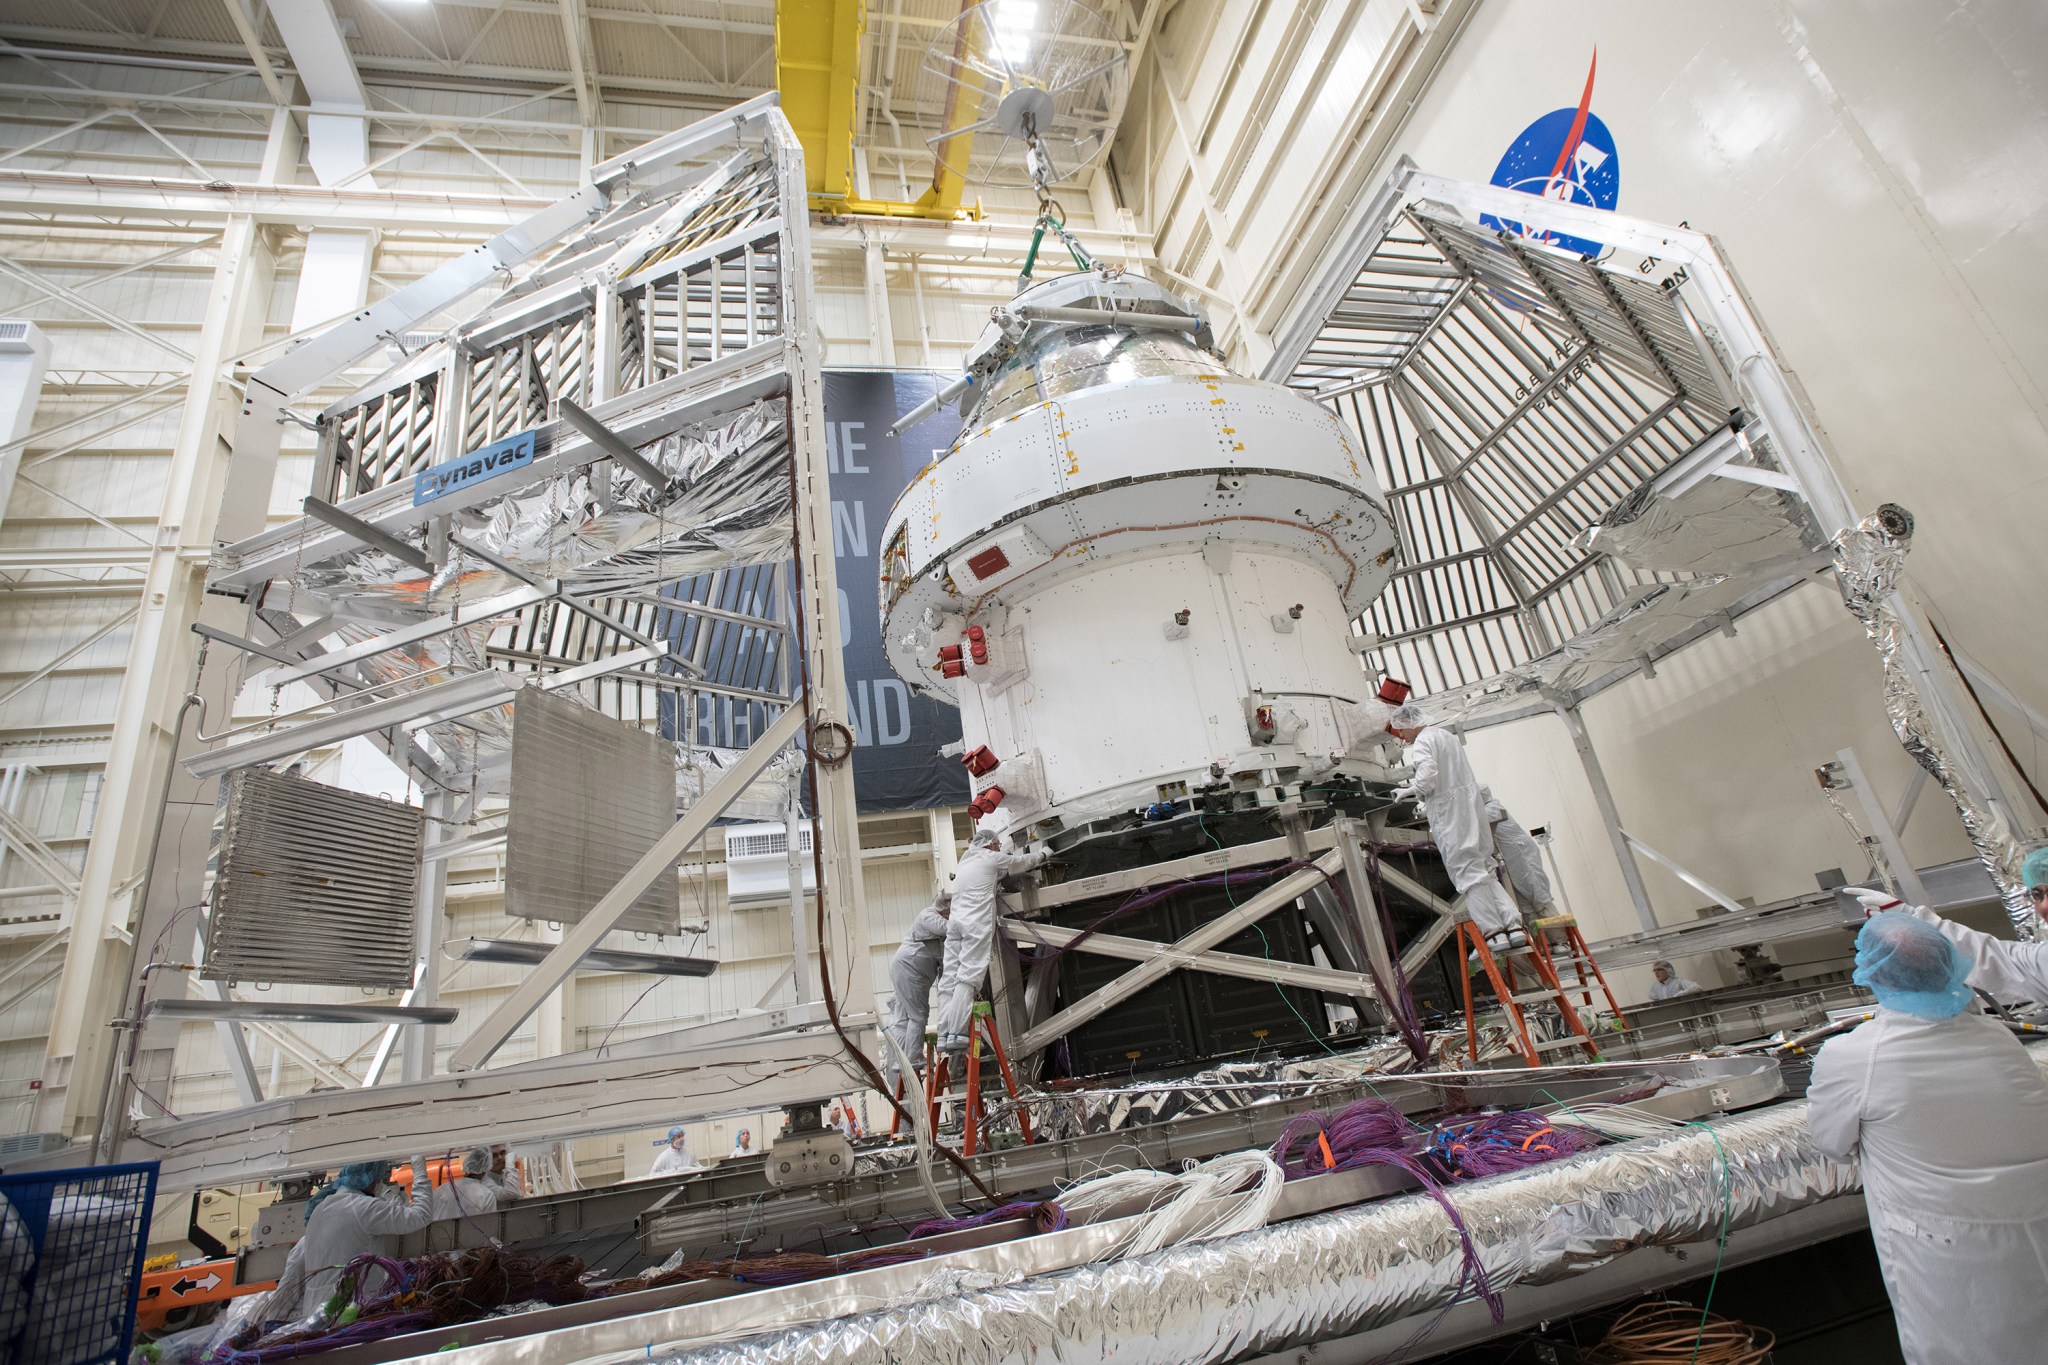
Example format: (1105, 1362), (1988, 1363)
(774, 0), (981, 223)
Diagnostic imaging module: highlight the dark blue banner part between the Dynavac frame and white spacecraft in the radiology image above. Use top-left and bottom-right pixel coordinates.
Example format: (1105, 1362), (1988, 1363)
(825, 370), (969, 810)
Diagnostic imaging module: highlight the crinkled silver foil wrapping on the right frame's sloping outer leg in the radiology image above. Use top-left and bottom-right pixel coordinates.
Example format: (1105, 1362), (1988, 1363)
(1835, 503), (2036, 941)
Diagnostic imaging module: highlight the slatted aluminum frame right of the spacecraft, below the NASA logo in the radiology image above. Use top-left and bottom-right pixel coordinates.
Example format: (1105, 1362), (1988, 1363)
(1264, 158), (2019, 931)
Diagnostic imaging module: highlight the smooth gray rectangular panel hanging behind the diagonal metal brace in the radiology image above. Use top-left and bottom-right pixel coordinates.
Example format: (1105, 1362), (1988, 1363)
(506, 688), (680, 933)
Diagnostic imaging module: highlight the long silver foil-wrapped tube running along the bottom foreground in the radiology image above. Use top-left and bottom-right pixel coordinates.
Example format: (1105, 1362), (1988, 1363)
(649, 1103), (1860, 1365)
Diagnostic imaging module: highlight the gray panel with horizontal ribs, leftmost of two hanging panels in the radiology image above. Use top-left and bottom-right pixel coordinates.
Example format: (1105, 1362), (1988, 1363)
(201, 767), (426, 990)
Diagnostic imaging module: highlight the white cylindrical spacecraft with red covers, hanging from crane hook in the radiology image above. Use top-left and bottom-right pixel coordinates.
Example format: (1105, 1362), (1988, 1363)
(881, 268), (1397, 841)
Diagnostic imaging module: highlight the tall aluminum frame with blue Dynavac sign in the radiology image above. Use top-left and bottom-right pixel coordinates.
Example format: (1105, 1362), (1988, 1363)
(100, 96), (874, 1179)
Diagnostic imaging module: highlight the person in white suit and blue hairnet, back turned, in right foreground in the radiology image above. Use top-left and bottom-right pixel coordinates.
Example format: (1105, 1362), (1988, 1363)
(1806, 911), (2048, 1365)
